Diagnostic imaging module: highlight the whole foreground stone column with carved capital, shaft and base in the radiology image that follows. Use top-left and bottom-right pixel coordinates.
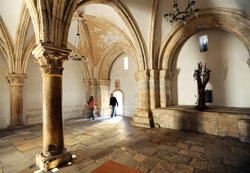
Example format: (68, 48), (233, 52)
(33, 44), (71, 170)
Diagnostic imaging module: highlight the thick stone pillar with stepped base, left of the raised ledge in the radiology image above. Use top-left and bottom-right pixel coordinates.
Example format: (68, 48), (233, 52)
(132, 70), (154, 128)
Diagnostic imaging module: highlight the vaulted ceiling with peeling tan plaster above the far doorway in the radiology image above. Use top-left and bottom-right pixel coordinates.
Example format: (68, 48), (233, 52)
(68, 4), (132, 66)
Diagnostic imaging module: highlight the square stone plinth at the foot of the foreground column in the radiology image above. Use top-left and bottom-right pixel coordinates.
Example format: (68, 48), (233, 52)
(36, 151), (72, 171)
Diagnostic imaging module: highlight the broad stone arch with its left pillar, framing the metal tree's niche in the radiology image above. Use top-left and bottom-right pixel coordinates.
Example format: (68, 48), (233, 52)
(158, 8), (250, 107)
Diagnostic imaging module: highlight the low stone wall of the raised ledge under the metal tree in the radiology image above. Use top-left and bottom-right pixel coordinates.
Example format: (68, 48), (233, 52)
(153, 108), (250, 141)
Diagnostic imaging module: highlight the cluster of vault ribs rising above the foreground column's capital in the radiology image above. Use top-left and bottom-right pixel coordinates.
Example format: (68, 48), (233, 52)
(25, 0), (79, 48)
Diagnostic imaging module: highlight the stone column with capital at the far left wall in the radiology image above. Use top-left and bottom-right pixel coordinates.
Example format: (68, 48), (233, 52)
(8, 74), (27, 128)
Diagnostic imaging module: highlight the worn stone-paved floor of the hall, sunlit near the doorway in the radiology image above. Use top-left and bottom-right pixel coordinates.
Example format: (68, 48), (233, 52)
(0, 117), (250, 173)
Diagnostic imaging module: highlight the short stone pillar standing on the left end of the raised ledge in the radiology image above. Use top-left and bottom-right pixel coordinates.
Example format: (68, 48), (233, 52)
(159, 70), (173, 108)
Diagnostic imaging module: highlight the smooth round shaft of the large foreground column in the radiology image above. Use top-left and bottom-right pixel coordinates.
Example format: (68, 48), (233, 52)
(43, 75), (64, 156)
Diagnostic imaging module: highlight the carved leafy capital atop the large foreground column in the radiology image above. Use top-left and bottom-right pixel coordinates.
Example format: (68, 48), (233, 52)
(32, 43), (71, 75)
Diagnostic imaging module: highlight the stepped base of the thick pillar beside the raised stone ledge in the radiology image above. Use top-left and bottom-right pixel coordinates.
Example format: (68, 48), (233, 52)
(131, 109), (154, 128)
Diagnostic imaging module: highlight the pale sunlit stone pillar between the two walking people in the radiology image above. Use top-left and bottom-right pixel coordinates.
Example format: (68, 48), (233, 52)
(97, 80), (110, 116)
